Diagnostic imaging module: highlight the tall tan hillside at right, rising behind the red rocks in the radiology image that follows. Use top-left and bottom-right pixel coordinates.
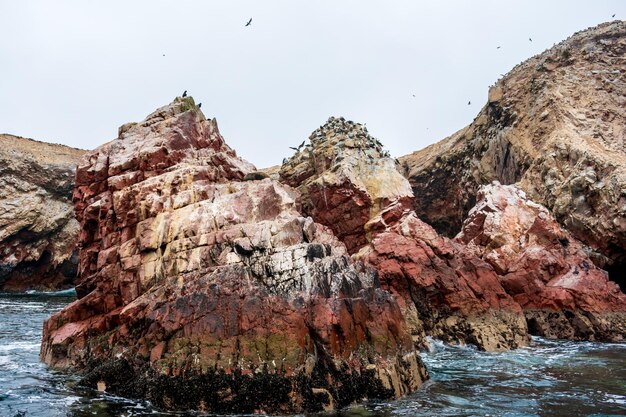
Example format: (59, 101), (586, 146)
(400, 21), (626, 284)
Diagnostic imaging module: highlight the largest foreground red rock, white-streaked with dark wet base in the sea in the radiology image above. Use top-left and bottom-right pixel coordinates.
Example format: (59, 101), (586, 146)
(41, 98), (427, 413)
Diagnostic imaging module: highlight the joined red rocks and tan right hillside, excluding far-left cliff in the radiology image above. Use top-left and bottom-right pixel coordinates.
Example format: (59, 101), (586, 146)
(24, 22), (626, 413)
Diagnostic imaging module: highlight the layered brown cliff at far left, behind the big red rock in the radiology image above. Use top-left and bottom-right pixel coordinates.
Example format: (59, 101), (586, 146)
(0, 135), (84, 292)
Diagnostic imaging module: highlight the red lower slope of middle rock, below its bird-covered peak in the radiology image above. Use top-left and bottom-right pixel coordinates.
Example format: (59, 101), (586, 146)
(357, 213), (528, 351)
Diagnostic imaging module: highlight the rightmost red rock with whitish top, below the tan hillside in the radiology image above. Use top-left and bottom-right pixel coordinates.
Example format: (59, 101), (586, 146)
(455, 182), (626, 341)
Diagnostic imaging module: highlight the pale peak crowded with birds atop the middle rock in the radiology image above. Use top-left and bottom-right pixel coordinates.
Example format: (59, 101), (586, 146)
(280, 117), (413, 252)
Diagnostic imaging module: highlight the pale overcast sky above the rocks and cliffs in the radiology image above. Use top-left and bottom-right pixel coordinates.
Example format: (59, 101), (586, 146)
(0, 0), (626, 167)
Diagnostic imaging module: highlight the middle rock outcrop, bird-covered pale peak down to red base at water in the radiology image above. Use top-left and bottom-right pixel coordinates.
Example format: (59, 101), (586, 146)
(280, 118), (527, 350)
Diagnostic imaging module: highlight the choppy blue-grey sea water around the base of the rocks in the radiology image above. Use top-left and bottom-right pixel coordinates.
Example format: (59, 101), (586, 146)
(0, 293), (626, 417)
